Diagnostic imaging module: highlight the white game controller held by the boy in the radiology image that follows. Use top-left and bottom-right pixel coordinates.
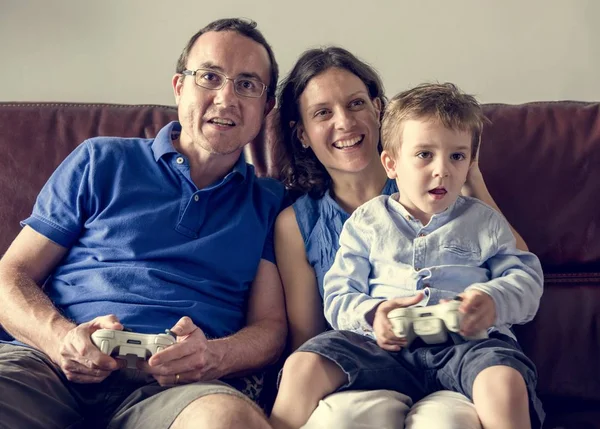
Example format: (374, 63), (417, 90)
(388, 297), (488, 346)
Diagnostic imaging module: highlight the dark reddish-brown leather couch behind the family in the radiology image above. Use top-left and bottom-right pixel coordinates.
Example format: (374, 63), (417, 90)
(0, 102), (600, 429)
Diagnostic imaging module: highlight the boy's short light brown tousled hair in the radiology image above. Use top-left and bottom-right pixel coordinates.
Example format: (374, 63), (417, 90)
(381, 83), (487, 160)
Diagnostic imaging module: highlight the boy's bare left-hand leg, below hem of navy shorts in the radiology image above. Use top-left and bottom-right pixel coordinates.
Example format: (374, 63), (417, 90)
(270, 352), (348, 429)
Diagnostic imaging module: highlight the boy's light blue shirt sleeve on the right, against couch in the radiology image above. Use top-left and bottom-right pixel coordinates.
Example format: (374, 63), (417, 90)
(466, 212), (544, 326)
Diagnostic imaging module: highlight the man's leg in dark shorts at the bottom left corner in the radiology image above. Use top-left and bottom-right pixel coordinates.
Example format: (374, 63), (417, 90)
(0, 344), (83, 429)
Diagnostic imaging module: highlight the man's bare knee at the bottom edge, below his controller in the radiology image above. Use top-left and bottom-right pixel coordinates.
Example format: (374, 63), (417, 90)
(170, 393), (270, 429)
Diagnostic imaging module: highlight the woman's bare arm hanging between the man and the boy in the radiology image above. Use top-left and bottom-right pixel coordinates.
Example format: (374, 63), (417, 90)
(275, 206), (326, 351)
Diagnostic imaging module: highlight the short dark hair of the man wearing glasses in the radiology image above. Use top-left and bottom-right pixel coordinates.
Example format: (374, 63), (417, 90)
(175, 18), (279, 98)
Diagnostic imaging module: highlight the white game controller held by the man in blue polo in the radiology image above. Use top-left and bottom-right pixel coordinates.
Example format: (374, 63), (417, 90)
(92, 329), (176, 368)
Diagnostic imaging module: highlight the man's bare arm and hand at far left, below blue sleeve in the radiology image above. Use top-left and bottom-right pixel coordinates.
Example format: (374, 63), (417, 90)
(0, 226), (123, 383)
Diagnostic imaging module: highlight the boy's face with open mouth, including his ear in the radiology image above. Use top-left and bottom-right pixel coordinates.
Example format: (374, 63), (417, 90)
(381, 119), (471, 225)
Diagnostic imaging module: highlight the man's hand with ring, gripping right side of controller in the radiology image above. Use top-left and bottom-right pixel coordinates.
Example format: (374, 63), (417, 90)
(139, 316), (220, 386)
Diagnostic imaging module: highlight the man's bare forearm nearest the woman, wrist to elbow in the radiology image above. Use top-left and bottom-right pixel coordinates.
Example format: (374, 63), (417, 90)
(209, 320), (287, 378)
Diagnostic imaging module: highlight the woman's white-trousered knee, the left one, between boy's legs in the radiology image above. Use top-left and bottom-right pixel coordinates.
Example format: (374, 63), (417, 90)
(303, 390), (412, 429)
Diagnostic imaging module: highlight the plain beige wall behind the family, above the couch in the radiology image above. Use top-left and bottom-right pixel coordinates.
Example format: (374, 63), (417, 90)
(0, 0), (600, 104)
